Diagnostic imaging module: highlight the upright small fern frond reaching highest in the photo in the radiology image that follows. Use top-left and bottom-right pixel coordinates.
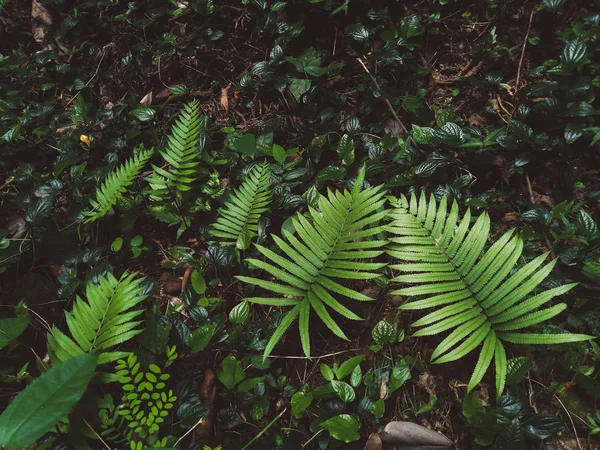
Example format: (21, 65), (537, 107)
(146, 100), (207, 198)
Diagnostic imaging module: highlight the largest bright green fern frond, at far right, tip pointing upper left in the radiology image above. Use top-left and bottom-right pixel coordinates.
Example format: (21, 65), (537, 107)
(388, 193), (592, 396)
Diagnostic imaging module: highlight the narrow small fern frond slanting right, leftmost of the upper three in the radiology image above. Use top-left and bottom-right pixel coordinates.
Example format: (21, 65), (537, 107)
(85, 149), (152, 223)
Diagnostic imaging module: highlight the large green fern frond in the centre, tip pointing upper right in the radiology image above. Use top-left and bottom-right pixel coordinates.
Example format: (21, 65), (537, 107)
(237, 168), (386, 358)
